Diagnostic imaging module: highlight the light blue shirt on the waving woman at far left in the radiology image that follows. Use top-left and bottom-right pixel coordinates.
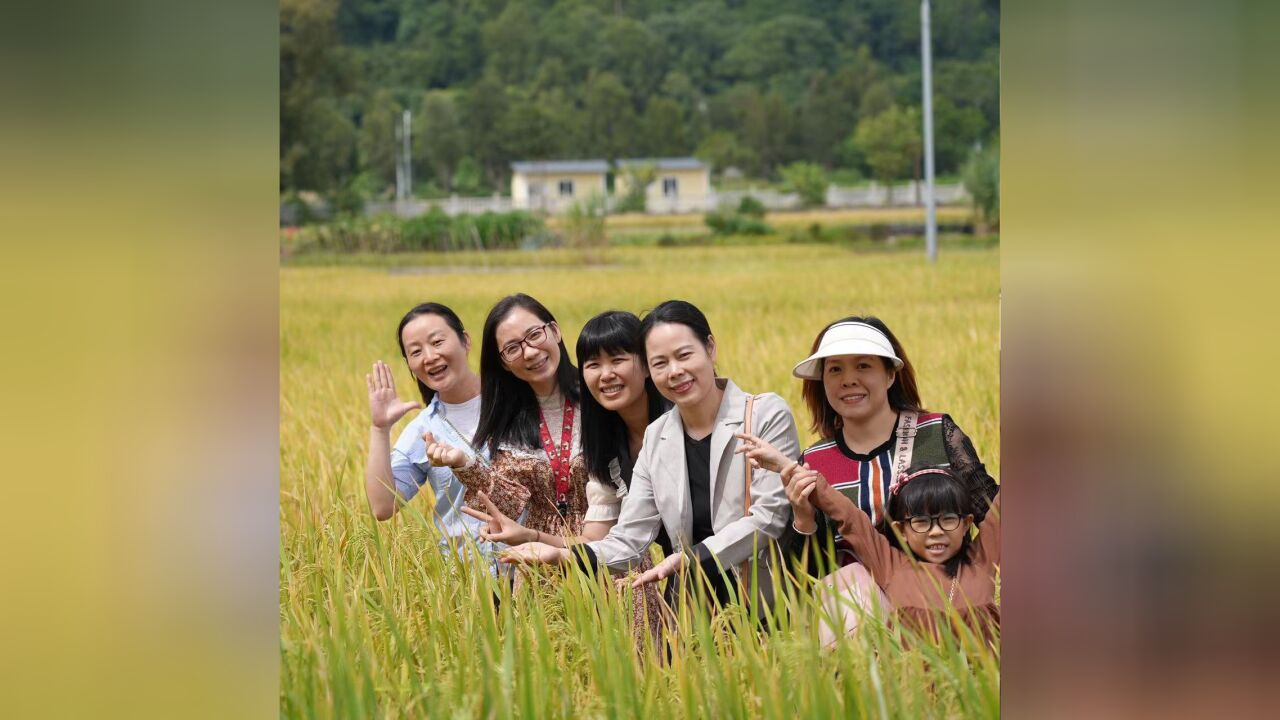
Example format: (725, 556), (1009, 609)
(392, 395), (507, 561)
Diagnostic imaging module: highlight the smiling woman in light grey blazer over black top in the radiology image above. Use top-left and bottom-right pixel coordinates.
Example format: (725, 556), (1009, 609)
(503, 300), (800, 600)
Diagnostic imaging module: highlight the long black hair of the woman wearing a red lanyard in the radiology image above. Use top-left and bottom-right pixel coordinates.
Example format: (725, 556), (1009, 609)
(472, 292), (580, 450)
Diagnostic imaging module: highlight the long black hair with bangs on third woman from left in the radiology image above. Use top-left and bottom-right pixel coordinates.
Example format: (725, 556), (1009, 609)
(577, 310), (669, 487)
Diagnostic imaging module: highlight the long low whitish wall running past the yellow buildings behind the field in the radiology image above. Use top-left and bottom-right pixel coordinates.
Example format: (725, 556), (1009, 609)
(355, 182), (969, 218)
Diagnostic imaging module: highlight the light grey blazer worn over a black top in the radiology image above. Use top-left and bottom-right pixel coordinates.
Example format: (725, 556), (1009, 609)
(589, 378), (800, 570)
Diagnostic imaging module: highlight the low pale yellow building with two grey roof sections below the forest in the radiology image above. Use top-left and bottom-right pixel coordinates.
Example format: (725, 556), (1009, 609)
(511, 158), (716, 213)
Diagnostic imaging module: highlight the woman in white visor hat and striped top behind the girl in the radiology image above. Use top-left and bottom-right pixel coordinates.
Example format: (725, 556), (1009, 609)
(744, 316), (997, 644)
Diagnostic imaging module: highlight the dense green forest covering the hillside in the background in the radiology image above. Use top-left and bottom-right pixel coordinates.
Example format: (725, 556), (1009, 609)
(280, 0), (1000, 202)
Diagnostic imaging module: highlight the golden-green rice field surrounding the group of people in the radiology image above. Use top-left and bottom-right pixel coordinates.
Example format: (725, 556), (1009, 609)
(280, 245), (1000, 719)
